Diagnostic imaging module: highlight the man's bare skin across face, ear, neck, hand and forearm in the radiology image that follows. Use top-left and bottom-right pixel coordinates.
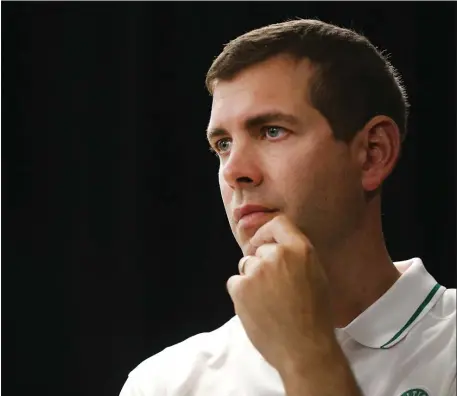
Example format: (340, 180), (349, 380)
(208, 56), (400, 396)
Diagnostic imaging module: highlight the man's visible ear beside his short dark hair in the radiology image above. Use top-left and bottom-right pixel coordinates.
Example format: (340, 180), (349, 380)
(355, 116), (401, 192)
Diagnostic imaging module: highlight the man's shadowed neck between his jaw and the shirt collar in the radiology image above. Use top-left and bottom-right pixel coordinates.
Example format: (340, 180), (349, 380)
(319, 197), (401, 328)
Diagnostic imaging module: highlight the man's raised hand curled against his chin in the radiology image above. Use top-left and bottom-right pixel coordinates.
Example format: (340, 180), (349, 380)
(227, 215), (336, 376)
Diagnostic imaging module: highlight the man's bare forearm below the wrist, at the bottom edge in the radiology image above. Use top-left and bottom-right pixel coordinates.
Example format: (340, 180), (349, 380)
(280, 338), (362, 396)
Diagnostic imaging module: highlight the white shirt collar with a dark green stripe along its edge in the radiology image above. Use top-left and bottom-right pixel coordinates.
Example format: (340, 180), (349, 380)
(341, 258), (445, 349)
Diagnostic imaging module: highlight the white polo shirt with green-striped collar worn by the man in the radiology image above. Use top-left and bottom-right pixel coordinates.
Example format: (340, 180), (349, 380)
(120, 258), (456, 396)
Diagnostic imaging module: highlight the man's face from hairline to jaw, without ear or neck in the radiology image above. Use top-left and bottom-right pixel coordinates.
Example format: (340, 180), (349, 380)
(208, 56), (364, 254)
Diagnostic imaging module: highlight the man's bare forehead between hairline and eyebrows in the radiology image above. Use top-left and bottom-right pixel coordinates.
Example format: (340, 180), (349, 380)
(209, 56), (312, 127)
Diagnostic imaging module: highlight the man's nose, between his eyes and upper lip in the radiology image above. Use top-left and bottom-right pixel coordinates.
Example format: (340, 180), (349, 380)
(221, 143), (262, 189)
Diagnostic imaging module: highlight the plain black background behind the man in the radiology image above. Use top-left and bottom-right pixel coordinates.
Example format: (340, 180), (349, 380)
(2, 2), (457, 395)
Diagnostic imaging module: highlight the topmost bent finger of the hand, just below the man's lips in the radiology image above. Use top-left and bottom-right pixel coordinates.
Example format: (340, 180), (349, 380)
(249, 216), (304, 249)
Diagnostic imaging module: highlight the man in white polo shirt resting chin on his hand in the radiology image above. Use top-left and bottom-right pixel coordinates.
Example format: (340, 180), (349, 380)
(121, 20), (456, 396)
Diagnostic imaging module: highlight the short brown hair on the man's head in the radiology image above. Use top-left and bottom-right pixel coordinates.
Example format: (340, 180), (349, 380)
(206, 19), (409, 142)
